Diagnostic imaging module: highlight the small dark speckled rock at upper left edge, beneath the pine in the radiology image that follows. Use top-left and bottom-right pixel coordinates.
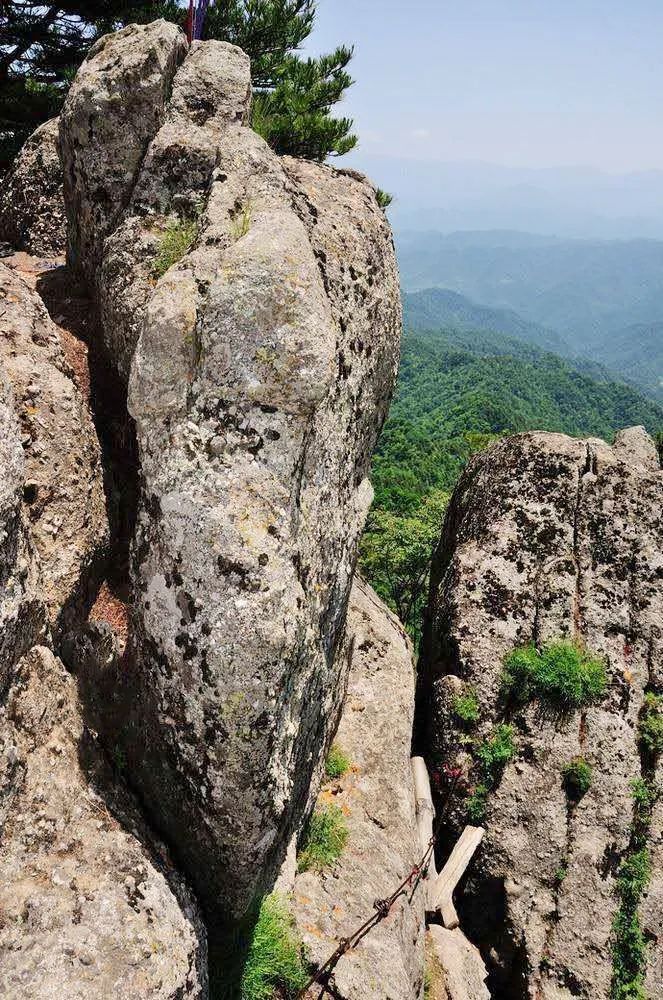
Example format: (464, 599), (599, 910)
(0, 118), (66, 257)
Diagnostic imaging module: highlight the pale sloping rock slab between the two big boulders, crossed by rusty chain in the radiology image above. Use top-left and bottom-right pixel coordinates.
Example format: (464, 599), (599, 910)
(293, 579), (424, 1000)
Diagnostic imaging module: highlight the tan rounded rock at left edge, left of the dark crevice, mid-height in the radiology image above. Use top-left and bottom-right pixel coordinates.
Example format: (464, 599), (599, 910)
(0, 264), (108, 645)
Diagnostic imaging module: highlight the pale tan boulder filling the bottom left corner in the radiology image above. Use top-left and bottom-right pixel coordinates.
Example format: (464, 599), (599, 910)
(0, 646), (207, 1000)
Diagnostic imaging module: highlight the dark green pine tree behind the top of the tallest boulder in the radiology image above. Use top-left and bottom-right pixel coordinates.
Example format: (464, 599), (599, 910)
(0, 0), (356, 169)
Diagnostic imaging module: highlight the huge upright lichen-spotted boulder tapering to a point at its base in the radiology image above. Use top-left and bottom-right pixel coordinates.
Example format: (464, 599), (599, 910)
(61, 22), (400, 917)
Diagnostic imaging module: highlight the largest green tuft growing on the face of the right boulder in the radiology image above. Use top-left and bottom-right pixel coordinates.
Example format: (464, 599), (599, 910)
(502, 640), (607, 713)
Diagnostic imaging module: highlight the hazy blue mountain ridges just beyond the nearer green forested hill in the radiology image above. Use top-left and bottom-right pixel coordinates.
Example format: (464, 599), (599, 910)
(397, 231), (663, 402)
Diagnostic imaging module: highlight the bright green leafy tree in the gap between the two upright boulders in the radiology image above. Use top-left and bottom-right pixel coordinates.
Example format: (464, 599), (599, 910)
(360, 490), (449, 641)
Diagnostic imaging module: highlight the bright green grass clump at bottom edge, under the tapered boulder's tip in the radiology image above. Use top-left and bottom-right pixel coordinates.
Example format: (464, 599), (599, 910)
(241, 892), (308, 1000)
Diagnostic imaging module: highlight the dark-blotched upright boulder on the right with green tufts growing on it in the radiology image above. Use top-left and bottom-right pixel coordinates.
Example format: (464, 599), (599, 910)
(418, 428), (663, 1000)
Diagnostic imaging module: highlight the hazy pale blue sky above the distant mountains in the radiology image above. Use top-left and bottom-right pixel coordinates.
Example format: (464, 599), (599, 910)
(309, 0), (663, 171)
